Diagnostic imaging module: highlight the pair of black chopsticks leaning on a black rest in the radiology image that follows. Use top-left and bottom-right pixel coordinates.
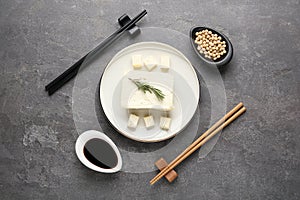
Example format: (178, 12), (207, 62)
(45, 10), (147, 96)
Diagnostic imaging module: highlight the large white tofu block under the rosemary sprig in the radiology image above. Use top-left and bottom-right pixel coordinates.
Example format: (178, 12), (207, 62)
(121, 70), (174, 111)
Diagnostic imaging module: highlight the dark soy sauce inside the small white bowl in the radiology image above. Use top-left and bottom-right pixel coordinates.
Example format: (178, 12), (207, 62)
(83, 138), (118, 169)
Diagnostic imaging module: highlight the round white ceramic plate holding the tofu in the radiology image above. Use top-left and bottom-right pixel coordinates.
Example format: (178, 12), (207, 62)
(100, 42), (200, 142)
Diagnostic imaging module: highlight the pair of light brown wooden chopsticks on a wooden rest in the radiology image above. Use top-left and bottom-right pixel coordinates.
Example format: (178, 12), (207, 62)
(150, 103), (246, 185)
